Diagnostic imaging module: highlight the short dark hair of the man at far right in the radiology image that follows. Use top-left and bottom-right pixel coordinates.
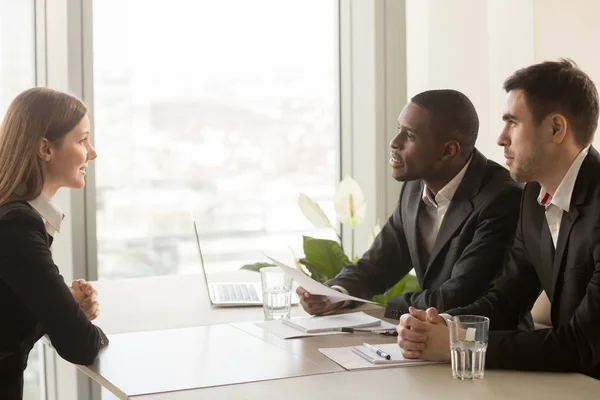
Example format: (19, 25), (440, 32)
(504, 59), (598, 146)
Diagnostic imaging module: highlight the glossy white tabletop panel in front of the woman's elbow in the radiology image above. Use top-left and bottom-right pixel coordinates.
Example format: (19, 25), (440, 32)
(80, 325), (339, 399)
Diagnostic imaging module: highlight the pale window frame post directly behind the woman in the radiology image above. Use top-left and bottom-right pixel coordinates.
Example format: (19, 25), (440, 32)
(36, 0), (99, 400)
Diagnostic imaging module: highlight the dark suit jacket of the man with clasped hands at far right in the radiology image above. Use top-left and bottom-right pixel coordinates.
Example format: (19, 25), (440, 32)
(448, 148), (600, 379)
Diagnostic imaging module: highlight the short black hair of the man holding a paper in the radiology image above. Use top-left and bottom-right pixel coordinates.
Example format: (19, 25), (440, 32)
(410, 89), (479, 158)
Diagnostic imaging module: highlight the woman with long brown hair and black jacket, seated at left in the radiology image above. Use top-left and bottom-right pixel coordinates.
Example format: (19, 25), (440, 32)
(0, 88), (108, 399)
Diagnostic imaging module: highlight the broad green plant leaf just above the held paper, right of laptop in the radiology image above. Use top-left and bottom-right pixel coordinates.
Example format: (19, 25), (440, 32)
(300, 236), (350, 282)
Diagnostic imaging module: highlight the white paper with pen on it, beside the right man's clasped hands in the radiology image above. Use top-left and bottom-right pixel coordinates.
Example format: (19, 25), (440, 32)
(319, 342), (437, 371)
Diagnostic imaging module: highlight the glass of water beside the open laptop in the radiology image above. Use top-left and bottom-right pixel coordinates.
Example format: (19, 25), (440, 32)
(260, 267), (292, 320)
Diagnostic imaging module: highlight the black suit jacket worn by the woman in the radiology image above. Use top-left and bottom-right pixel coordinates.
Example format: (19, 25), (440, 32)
(0, 201), (108, 400)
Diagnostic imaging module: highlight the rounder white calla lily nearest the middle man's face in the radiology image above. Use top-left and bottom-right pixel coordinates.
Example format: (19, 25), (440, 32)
(334, 175), (367, 229)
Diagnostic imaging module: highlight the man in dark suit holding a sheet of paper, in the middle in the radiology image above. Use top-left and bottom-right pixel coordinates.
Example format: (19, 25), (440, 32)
(298, 90), (522, 319)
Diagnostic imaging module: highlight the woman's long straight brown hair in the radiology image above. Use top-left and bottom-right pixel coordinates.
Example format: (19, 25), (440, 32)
(0, 87), (87, 205)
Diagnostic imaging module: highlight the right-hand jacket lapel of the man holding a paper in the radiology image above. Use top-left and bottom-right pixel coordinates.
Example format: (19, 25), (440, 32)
(425, 149), (487, 282)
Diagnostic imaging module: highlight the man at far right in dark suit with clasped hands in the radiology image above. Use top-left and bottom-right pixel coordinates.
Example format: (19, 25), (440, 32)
(397, 60), (600, 379)
